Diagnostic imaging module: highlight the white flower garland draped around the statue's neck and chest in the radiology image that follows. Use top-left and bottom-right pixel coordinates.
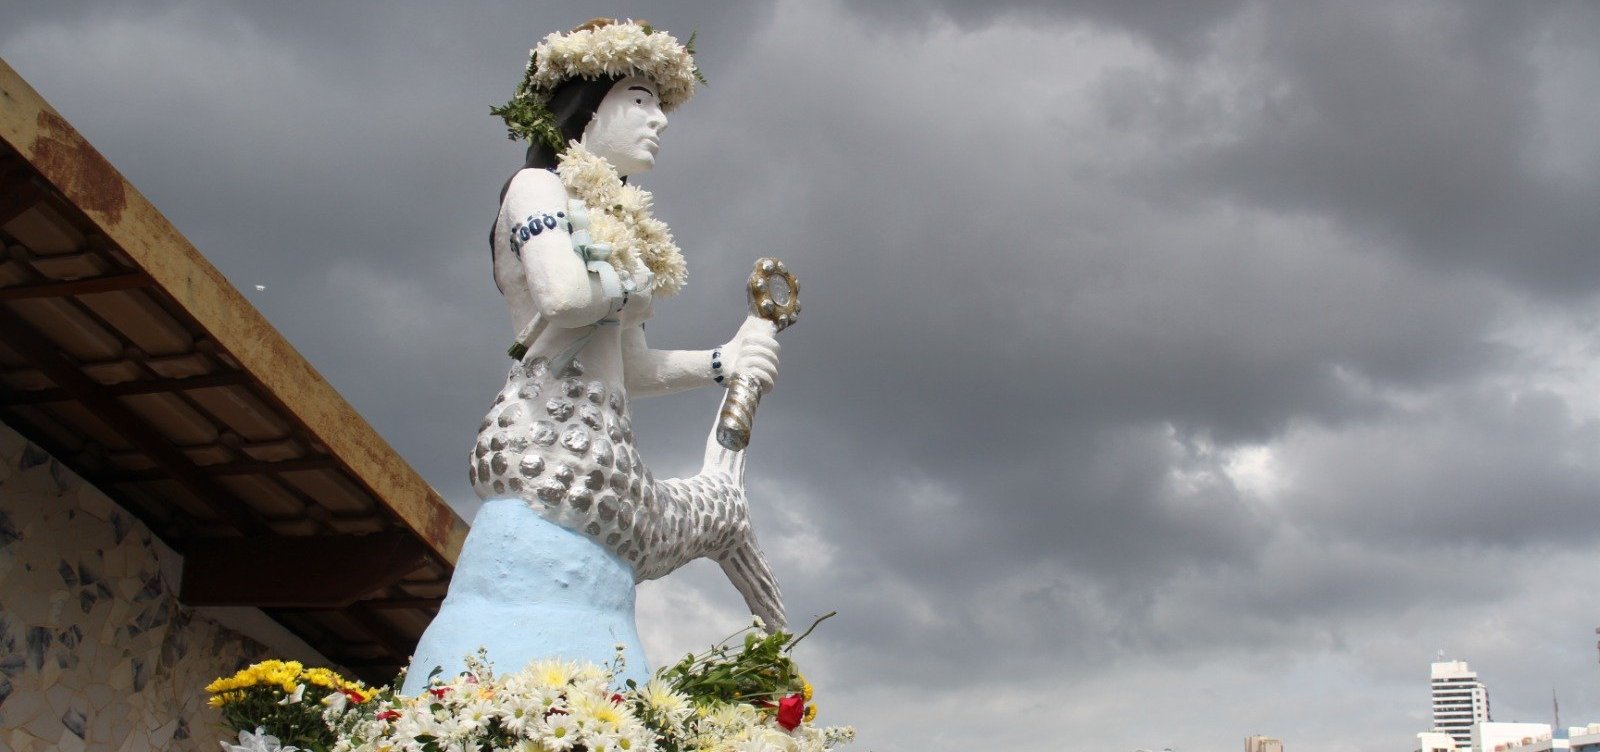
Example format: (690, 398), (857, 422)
(555, 140), (690, 298)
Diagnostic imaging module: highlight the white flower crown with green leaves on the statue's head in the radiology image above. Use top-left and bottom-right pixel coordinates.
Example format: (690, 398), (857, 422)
(490, 18), (706, 152)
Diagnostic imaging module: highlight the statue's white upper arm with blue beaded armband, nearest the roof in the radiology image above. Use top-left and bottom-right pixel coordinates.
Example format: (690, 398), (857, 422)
(499, 170), (611, 328)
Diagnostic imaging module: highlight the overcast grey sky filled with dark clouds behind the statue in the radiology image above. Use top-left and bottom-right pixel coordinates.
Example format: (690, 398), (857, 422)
(0, 0), (1600, 752)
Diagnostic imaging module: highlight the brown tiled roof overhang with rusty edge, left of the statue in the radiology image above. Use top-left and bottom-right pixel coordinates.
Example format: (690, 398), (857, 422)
(0, 61), (467, 680)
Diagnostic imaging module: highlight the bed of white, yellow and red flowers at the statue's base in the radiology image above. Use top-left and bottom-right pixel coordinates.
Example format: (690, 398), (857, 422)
(217, 614), (854, 752)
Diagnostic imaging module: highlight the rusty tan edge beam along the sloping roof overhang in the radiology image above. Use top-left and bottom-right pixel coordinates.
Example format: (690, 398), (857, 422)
(0, 59), (467, 565)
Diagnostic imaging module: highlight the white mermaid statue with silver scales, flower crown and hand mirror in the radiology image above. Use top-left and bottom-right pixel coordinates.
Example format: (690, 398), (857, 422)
(402, 19), (798, 694)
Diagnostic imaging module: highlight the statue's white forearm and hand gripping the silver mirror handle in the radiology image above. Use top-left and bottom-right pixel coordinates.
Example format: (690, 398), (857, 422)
(622, 317), (778, 397)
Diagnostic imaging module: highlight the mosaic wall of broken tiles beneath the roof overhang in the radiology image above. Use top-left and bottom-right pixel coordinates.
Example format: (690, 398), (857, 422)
(0, 424), (266, 752)
